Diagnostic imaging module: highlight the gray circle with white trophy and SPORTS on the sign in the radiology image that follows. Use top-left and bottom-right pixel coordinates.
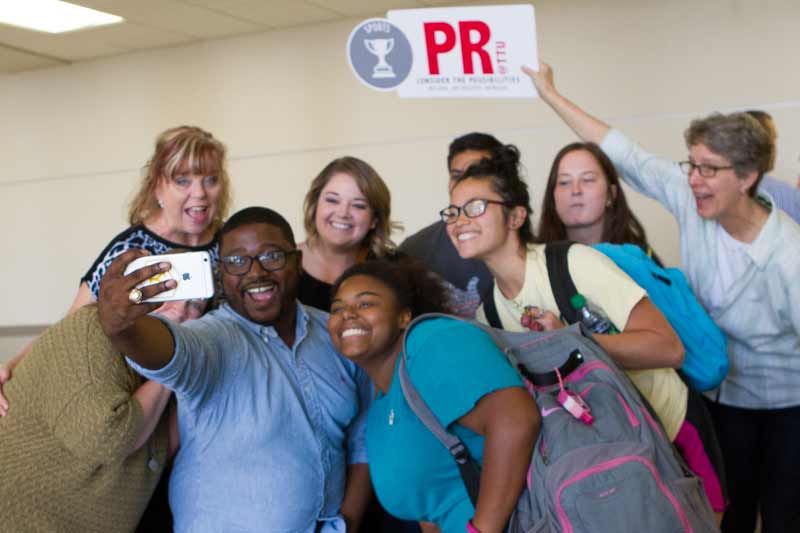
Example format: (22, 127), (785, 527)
(347, 19), (414, 91)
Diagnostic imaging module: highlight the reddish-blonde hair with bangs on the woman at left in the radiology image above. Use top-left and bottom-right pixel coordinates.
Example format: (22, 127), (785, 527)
(128, 126), (231, 231)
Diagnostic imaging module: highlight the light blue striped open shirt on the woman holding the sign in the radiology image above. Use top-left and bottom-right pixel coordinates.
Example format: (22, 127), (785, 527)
(601, 130), (800, 409)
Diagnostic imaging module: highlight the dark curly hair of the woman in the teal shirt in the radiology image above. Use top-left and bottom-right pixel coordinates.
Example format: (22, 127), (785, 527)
(331, 257), (453, 318)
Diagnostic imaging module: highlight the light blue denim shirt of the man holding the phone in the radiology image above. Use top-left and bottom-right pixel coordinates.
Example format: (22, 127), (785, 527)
(129, 303), (371, 533)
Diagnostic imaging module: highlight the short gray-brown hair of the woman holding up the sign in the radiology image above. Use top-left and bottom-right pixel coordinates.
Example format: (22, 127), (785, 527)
(683, 113), (773, 197)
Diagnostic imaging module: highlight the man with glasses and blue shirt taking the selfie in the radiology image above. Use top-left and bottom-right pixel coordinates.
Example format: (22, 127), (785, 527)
(98, 207), (370, 533)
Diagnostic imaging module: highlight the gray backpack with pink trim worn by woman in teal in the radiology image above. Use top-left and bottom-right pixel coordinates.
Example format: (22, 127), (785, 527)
(399, 314), (719, 533)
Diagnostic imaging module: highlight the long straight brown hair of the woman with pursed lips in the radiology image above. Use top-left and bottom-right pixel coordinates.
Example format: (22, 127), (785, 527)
(539, 142), (650, 250)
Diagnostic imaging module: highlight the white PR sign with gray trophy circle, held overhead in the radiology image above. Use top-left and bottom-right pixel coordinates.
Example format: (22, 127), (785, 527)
(348, 5), (539, 98)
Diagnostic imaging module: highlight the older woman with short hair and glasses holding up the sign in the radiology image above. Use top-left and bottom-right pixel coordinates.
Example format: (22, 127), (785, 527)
(525, 64), (800, 533)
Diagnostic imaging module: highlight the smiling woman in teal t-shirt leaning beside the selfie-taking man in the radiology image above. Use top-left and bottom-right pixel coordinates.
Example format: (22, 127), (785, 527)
(328, 261), (541, 533)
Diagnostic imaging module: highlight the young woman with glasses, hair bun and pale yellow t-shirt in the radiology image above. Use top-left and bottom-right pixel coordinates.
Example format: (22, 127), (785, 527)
(441, 146), (724, 510)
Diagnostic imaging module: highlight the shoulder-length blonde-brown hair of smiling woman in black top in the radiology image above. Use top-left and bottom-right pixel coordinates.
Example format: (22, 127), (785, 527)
(303, 156), (403, 258)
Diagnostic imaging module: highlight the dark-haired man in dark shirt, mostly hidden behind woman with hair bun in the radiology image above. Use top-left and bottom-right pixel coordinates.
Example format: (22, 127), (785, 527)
(400, 133), (502, 317)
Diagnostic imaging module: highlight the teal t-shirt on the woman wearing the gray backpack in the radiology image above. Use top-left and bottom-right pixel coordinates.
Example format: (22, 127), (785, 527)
(367, 318), (523, 533)
